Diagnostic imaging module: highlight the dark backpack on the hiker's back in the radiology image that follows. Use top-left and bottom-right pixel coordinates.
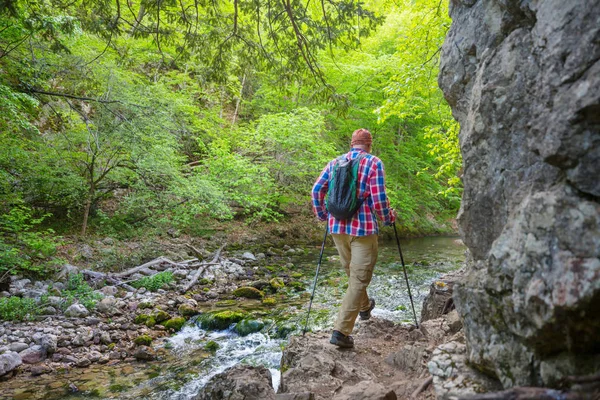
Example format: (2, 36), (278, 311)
(326, 154), (364, 220)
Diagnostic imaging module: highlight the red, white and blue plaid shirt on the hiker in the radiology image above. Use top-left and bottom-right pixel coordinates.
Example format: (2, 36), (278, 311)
(311, 148), (395, 236)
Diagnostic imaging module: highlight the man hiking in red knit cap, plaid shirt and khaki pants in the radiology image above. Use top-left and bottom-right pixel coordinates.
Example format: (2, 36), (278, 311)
(312, 129), (396, 347)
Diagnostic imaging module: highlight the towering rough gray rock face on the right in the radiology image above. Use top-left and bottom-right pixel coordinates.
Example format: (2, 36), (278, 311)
(439, 0), (600, 387)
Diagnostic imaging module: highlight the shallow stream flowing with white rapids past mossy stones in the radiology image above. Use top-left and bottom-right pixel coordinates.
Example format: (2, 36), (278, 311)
(0, 237), (465, 400)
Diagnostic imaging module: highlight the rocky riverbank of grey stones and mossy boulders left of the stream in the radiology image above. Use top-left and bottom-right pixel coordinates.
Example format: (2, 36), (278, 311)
(0, 246), (304, 380)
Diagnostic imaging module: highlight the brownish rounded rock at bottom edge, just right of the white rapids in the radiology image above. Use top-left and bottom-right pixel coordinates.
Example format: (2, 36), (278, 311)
(194, 365), (275, 400)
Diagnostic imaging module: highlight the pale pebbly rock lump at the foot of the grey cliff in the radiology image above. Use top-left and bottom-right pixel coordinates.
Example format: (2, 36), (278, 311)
(427, 342), (501, 400)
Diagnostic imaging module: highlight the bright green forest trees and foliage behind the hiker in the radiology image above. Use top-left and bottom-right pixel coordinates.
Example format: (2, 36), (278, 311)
(0, 0), (461, 272)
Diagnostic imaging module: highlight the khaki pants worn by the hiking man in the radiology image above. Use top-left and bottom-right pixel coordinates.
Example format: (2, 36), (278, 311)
(331, 234), (378, 336)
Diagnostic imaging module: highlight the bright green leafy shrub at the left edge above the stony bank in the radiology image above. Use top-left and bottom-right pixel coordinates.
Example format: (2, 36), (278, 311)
(0, 206), (60, 275)
